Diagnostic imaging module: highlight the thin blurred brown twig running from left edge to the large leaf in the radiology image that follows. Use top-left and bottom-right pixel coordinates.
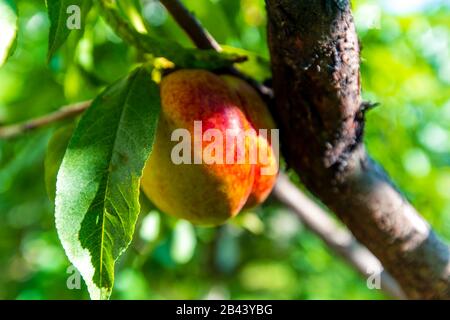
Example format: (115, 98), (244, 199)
(0, 101), (92, 139)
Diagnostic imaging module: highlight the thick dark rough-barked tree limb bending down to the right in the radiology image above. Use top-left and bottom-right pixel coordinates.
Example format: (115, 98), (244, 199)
(266, 0), (450, 299)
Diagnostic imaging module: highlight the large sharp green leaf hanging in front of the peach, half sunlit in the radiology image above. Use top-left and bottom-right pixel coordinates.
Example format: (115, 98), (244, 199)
(55, 69), (160, 299)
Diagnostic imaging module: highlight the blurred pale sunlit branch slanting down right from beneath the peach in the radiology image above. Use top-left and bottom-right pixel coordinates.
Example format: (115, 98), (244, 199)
(272, 174), (406, 299)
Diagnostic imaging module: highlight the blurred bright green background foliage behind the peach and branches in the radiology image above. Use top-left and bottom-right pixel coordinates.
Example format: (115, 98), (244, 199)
(0, 0), (450, 299)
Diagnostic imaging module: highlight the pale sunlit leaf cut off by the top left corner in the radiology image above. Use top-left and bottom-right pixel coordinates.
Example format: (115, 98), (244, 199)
(0, 0), (18, 67)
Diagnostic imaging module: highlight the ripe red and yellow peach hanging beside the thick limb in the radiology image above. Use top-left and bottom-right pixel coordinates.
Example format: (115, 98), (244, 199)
(141, 70), (278, 226)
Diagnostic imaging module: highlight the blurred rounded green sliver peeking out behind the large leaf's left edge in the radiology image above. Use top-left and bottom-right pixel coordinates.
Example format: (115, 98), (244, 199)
(45, 123), (75, 201)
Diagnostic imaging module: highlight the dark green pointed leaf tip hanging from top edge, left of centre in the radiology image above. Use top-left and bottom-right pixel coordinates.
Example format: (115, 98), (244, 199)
(46, 0), (92, 60)
